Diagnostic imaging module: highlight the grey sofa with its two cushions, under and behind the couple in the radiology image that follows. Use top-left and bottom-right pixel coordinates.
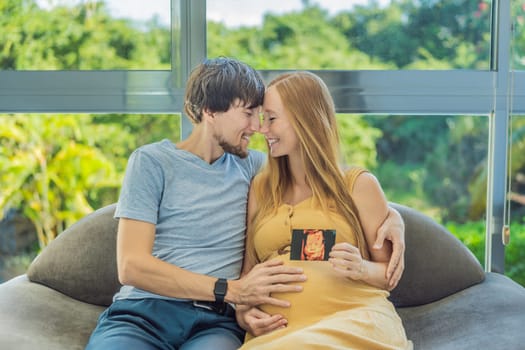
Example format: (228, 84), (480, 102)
(0, 203), (525, 350)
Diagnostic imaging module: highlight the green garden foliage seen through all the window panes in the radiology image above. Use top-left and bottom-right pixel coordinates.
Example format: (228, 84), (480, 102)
(0, 0), (525, 285)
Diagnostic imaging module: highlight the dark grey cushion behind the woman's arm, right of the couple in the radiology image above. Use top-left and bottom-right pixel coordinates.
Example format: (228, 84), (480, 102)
(390, 203), (485, 307)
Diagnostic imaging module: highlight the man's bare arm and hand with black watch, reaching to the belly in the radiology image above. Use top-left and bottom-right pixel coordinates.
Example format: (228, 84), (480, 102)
(117, 218), (304, 307)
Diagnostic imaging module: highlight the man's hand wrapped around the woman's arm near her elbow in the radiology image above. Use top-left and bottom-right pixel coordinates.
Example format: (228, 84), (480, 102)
(374, 207), (405, 290)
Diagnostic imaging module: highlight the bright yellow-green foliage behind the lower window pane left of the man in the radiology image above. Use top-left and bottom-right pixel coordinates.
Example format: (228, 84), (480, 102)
(0, 114), (180, 248)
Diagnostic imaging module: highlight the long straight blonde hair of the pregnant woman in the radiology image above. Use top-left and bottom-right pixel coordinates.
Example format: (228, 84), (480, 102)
(250, 71), (369, 258)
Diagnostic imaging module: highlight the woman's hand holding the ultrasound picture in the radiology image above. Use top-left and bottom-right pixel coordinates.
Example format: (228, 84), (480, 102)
(328, 242), (367, 280)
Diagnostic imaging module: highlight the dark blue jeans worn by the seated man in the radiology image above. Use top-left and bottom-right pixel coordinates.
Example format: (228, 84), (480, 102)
(86, 298), (244, 350)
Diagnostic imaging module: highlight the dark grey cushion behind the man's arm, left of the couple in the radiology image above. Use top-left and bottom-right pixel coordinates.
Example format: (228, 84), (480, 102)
(27, 204), (120, 306)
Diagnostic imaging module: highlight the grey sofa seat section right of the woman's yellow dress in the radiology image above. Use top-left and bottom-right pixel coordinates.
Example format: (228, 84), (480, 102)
(397, 272), (525, 350)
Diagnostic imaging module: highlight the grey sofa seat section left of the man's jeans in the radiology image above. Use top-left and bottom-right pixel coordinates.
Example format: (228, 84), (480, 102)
(0, 275), (104, 350)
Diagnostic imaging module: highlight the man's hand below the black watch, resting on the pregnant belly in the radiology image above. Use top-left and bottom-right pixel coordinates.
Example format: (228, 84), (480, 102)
(230, 258), (306, 307)
